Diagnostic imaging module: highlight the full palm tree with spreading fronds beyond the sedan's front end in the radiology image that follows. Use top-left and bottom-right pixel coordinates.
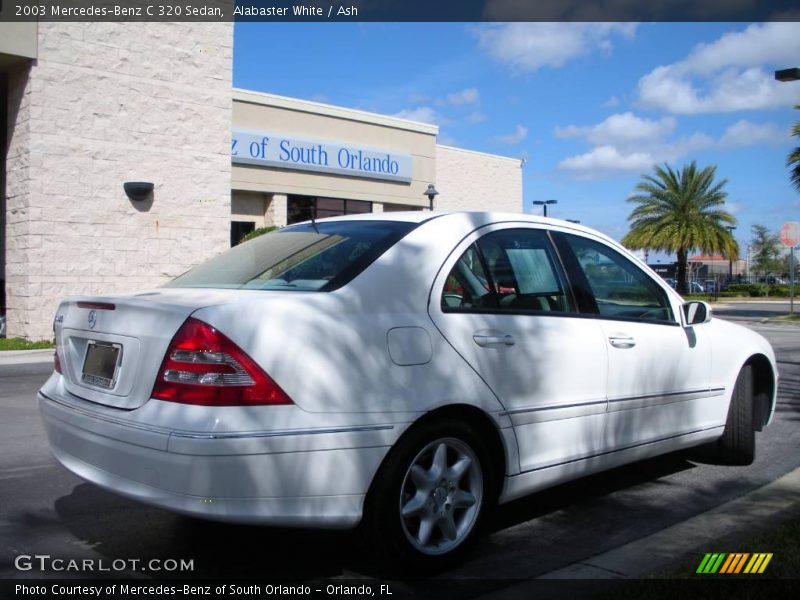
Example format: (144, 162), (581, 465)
(622, 162), (739, 294)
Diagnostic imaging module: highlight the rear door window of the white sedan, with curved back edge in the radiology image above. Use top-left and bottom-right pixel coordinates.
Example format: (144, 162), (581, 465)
(442, 229), (574, 313)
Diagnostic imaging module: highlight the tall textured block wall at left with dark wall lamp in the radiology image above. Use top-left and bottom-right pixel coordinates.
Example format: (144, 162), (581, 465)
(6, 22), (233, 339)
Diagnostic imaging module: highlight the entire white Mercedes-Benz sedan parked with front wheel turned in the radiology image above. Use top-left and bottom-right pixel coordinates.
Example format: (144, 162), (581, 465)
(38, 212), (777, 569)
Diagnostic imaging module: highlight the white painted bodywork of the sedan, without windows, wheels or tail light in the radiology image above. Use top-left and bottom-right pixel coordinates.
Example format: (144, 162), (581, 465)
(38, 212), (777, 564)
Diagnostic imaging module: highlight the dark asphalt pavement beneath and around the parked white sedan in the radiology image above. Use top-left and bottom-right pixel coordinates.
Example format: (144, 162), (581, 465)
(0, 305), (800, 597)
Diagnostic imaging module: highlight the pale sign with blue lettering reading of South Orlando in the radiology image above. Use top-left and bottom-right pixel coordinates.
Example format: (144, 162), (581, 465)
(231, 129), (411, 183)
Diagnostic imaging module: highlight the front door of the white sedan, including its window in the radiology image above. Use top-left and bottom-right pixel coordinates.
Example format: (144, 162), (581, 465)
(557, 234), (723, 448)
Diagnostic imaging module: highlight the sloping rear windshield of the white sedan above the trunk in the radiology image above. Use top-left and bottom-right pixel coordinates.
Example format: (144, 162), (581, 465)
(165, 221), (417, 292)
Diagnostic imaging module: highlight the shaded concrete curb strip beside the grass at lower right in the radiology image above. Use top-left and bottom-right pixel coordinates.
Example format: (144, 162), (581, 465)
(488, 468), (800, 597)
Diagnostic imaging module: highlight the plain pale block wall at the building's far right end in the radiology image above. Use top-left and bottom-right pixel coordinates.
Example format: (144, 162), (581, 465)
(433, 146), (523, 212)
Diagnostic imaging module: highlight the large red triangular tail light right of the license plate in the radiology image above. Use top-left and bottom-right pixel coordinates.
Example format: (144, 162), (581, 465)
(152, 318), (292, 406)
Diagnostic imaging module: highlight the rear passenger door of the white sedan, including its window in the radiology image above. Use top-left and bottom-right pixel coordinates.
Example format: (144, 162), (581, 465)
(429, 224), (607, 472)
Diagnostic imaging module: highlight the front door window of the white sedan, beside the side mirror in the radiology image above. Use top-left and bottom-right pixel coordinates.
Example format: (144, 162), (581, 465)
(563, 234), (674, 322)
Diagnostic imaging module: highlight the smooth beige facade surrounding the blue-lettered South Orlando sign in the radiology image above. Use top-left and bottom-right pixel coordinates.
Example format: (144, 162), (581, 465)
(232, 90), (439, 218)
